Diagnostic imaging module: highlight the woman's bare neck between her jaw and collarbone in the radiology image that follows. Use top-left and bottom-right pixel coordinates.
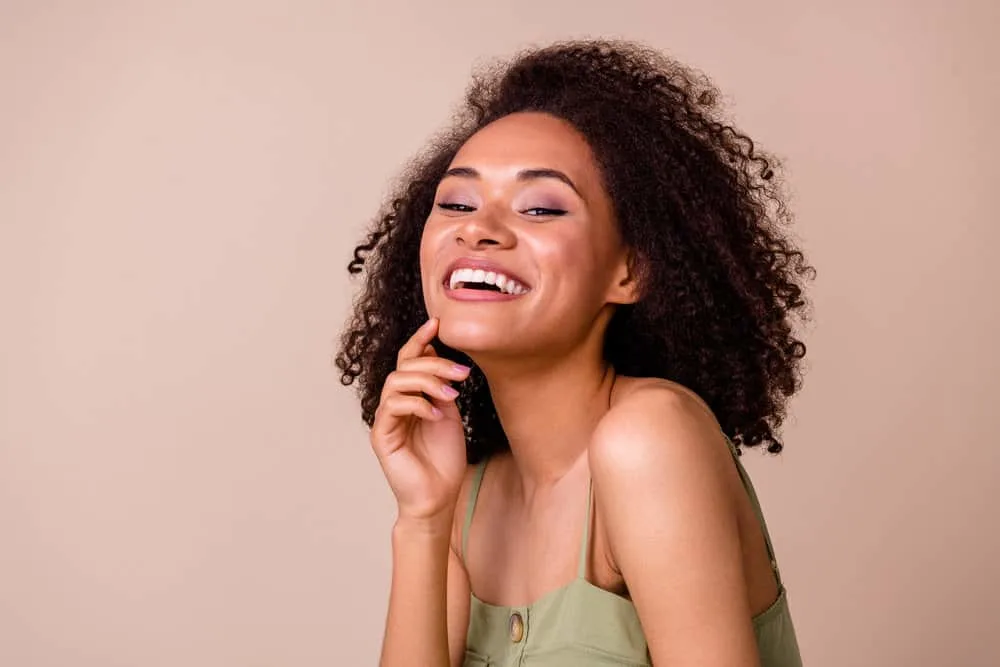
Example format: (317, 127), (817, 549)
(481, 345), (615, 490)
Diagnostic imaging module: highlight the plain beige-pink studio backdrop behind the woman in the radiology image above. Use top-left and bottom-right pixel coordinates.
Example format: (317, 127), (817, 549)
(0, 0), (1000, 667)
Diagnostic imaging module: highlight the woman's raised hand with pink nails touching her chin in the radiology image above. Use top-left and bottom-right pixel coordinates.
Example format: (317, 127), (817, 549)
(371, 318), (469, 520)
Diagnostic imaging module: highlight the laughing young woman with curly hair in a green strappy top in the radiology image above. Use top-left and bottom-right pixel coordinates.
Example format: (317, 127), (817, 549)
(337, 42), (811, 667)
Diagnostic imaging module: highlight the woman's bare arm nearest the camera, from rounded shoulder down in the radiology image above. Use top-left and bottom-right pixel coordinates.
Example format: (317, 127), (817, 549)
(590, 387), (759, 667)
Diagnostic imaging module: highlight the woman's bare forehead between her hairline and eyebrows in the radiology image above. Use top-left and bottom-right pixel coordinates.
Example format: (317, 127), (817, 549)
(452, 112), (599, 186)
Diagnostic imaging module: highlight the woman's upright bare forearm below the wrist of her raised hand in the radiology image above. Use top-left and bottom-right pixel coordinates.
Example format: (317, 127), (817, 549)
(380, 516), (451, 667)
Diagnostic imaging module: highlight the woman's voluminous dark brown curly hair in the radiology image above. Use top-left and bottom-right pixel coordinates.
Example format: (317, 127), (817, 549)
(336, 40), (814, 462)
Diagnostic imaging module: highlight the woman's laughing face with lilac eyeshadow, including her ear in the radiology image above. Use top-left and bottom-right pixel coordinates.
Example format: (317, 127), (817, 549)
(420, 113), (634, 359)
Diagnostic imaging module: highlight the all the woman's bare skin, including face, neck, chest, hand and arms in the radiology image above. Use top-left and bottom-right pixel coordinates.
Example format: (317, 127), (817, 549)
(371, 113), (778, 667)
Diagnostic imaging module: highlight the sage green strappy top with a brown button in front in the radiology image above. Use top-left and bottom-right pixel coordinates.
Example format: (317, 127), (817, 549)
(462, 438), (802, 667)
